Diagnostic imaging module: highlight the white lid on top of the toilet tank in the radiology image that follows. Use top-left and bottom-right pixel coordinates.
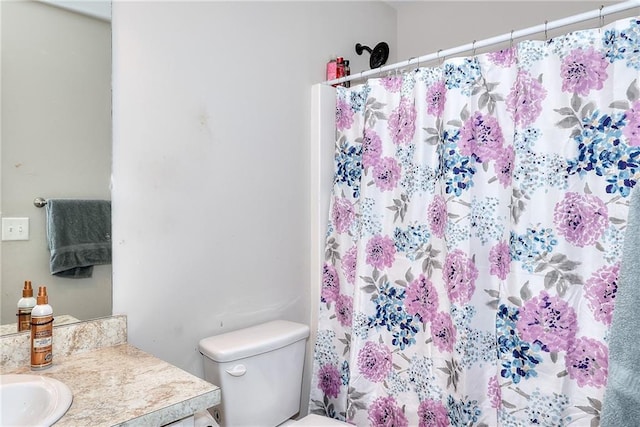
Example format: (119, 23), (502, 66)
(198, 320), (309, 362)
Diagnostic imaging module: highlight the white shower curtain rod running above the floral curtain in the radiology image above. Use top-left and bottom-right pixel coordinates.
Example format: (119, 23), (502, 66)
(323, 0), (640, 85)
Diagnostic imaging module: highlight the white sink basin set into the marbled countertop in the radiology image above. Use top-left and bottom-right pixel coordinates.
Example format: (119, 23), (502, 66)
(0, 374), (73, 427)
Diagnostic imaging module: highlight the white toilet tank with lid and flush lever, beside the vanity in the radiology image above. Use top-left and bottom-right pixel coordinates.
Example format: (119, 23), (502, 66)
(199, 320), (309, 427)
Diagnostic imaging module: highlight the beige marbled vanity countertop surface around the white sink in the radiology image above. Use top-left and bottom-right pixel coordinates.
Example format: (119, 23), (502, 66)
(5, 344), (220, 427)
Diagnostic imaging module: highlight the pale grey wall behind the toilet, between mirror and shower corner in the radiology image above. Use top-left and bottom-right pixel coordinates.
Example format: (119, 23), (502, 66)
(112, 2), (396, 416)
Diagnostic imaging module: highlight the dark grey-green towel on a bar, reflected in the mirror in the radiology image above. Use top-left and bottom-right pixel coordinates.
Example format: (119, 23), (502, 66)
(46, 199), (111, 279)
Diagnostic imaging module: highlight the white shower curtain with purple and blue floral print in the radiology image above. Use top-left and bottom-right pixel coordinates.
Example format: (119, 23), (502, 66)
(309, 18), (640, 427)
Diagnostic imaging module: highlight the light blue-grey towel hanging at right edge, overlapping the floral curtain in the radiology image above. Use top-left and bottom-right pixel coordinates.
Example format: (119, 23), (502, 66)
(600, 189), (640, 427)
